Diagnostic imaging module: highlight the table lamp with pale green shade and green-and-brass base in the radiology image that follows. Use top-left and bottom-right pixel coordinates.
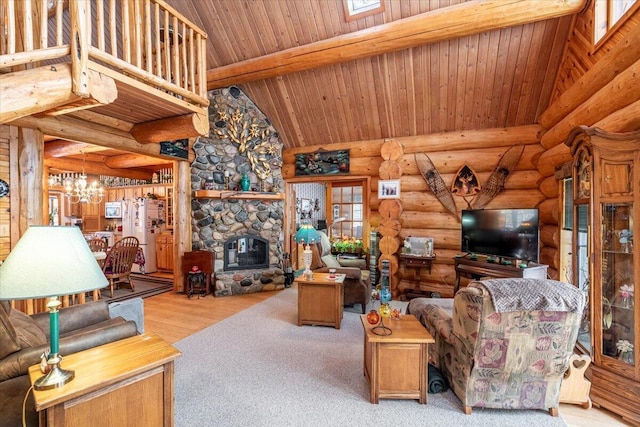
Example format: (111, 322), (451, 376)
(0, 226), (109, 390)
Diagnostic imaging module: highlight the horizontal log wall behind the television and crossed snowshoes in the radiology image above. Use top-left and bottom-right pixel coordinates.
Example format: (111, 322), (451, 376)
(283, 125), (546, 296)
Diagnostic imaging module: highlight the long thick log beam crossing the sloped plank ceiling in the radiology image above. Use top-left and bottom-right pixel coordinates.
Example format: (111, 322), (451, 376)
(207, 0), (587, 89)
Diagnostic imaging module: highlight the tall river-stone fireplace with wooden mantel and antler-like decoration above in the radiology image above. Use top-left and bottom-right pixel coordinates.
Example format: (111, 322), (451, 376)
(191, 87), (284, 296)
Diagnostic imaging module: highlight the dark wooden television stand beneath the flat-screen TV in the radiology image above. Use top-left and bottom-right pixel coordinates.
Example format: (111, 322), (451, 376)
(453, 257), (548, 295)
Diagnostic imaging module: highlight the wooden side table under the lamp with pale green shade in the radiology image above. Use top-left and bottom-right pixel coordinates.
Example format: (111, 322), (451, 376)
(29, 334), (180, 427)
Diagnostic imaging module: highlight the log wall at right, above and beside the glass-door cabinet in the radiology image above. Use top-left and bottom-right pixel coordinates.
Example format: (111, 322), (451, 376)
(533, 8), (640, 279)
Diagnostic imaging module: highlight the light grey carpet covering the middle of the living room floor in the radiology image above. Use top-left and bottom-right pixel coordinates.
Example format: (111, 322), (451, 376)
(175, 288), (566, 427)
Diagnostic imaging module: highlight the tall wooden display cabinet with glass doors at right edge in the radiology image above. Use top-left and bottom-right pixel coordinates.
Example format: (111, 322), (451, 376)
(567, 127), (640, 424)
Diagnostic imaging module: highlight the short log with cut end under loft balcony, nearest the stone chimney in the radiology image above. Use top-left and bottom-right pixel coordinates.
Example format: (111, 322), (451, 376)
(131, 113), (209, 144)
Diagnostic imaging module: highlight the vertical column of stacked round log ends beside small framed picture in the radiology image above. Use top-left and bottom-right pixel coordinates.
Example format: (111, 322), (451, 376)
(378, 139), (404, 298)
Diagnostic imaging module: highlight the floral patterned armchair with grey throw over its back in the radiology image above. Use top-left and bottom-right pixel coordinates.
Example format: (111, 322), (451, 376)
(407, 279), (585, 416)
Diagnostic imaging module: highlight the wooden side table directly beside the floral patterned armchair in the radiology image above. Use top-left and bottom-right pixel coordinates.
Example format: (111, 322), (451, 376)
(360, 314), (435, 404)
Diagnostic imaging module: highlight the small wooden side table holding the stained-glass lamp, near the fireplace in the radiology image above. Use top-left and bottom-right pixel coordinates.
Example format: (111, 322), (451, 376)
(295, 273), (346, 329)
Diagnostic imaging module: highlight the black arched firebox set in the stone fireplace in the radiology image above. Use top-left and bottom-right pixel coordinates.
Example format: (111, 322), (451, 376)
(224, 235), (269, 271)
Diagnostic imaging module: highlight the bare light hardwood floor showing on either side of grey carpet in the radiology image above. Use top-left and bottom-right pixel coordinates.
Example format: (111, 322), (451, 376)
(144, 291), (631, 427)
